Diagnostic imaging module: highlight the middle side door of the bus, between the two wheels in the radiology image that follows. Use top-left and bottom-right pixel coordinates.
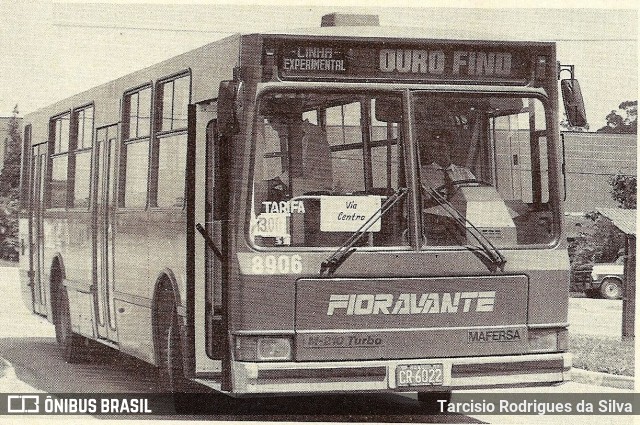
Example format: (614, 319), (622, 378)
(93, 125), (118, 341)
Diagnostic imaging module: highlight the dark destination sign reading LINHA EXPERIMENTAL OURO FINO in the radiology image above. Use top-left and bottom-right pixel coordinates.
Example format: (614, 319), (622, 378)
(279, 43), (531, 83)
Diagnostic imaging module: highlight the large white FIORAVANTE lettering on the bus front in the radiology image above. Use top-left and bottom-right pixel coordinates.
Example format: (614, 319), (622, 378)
(327, 291), (496, 316)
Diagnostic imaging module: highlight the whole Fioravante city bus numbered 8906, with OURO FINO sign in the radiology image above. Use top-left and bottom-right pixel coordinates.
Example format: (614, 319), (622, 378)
(19, 14), (584, 402)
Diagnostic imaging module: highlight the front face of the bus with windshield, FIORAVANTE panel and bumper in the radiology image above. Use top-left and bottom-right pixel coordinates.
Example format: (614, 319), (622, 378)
(218, 36), (571, 393)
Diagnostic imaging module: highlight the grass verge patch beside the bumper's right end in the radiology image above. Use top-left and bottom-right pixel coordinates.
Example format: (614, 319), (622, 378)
(569, 335), (635, 376)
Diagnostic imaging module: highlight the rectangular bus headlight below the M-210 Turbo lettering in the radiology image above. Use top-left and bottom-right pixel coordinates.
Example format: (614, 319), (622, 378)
(236, 336), (292, 362)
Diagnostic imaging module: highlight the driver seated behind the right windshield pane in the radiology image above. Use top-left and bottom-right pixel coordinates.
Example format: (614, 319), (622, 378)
(420, 130), (476, 189)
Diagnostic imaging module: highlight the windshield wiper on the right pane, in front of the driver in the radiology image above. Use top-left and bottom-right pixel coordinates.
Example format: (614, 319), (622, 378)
(422, 185), (507, 272)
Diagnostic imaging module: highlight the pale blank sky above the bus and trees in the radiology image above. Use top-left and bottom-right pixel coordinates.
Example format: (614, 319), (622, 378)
(0, 0), (638, 131)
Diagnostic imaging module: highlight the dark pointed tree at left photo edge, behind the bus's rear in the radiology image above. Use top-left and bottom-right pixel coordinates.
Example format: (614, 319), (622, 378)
(0, 105), (22, 261)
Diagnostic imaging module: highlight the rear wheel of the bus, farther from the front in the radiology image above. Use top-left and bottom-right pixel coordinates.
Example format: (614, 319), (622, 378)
(54, 285), (88, 363)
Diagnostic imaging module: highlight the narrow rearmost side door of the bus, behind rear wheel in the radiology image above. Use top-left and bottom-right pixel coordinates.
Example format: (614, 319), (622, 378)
(29, 143), (47, 314)
